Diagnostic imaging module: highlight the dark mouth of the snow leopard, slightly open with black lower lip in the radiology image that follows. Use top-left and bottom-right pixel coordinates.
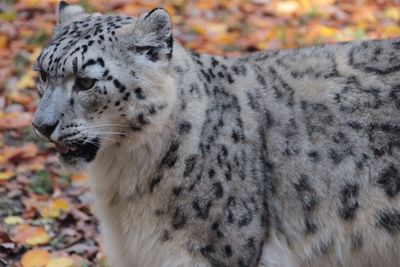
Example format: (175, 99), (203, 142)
(54, 138), (100, 162)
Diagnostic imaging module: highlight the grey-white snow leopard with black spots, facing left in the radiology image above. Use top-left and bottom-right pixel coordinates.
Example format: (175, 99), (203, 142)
(33, 1), (400, 267)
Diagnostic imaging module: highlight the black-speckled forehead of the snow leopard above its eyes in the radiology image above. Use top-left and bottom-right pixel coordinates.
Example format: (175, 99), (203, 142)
(37, 15), (135, 76)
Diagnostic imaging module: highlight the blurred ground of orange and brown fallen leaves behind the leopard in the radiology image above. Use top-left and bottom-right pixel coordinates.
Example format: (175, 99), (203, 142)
(0, 0), (400, 267)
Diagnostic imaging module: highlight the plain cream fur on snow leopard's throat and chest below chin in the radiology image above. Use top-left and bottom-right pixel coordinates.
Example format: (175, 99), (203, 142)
(89, 143), (206, 267)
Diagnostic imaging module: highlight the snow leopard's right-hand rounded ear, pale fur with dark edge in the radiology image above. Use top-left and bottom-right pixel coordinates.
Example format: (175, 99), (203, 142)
(120, 8), (173, 61)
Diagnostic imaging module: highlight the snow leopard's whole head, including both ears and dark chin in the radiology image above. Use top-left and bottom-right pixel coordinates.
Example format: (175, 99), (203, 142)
(33, 1), (176, 168)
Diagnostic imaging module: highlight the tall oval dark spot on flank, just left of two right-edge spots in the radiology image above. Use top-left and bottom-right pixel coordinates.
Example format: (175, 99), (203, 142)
(339, 183), (359, 220)
